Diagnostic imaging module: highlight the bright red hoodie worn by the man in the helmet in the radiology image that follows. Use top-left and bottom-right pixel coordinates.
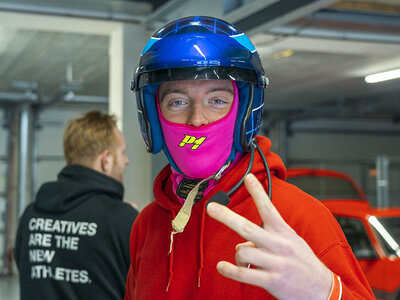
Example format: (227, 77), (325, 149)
(125, 136), (374, 300)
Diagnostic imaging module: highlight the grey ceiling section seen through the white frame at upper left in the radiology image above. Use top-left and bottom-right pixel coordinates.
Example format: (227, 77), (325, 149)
(0, 30), (108, 97)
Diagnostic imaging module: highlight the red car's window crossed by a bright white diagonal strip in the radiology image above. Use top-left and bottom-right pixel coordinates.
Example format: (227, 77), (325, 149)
(368, 216), (400, 257)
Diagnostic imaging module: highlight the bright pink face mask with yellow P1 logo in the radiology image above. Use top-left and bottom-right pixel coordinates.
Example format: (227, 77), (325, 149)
(157, 81), (239, 178)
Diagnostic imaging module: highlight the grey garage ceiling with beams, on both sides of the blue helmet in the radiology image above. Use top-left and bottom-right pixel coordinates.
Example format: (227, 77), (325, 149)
(0, 0), (400, 123)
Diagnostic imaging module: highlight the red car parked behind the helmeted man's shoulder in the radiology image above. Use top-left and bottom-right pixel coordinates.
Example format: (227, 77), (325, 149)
(287, 168), (400, 300)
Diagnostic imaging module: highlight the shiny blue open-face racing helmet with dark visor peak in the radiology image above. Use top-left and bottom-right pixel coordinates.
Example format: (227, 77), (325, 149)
(131, 16), (268, 158)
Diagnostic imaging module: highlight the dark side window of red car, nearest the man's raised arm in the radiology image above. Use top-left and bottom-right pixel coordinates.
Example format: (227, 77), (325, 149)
(336, 217), (376, 259)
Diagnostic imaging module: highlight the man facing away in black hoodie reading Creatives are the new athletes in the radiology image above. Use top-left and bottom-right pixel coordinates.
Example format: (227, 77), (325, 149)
(14, 111), (138, 300)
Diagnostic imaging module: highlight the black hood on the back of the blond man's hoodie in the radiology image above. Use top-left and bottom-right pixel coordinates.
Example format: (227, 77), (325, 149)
(34, 165), (124, 213)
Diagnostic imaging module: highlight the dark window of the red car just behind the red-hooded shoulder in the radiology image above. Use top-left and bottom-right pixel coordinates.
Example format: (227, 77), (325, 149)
(287, 176), (360, 200)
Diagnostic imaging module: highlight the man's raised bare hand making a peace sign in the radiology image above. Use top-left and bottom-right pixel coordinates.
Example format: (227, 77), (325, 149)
(207, 174), (332, 299)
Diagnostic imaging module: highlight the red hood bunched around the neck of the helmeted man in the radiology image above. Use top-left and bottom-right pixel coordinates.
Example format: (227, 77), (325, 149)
(153, 136), (286, 215)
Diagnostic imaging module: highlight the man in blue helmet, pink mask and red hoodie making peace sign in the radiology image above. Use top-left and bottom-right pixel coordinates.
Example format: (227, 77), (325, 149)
(125, 17), (374, 300)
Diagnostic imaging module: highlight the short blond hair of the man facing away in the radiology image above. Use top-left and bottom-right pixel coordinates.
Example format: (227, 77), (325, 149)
(63, 111), (117, 166)
